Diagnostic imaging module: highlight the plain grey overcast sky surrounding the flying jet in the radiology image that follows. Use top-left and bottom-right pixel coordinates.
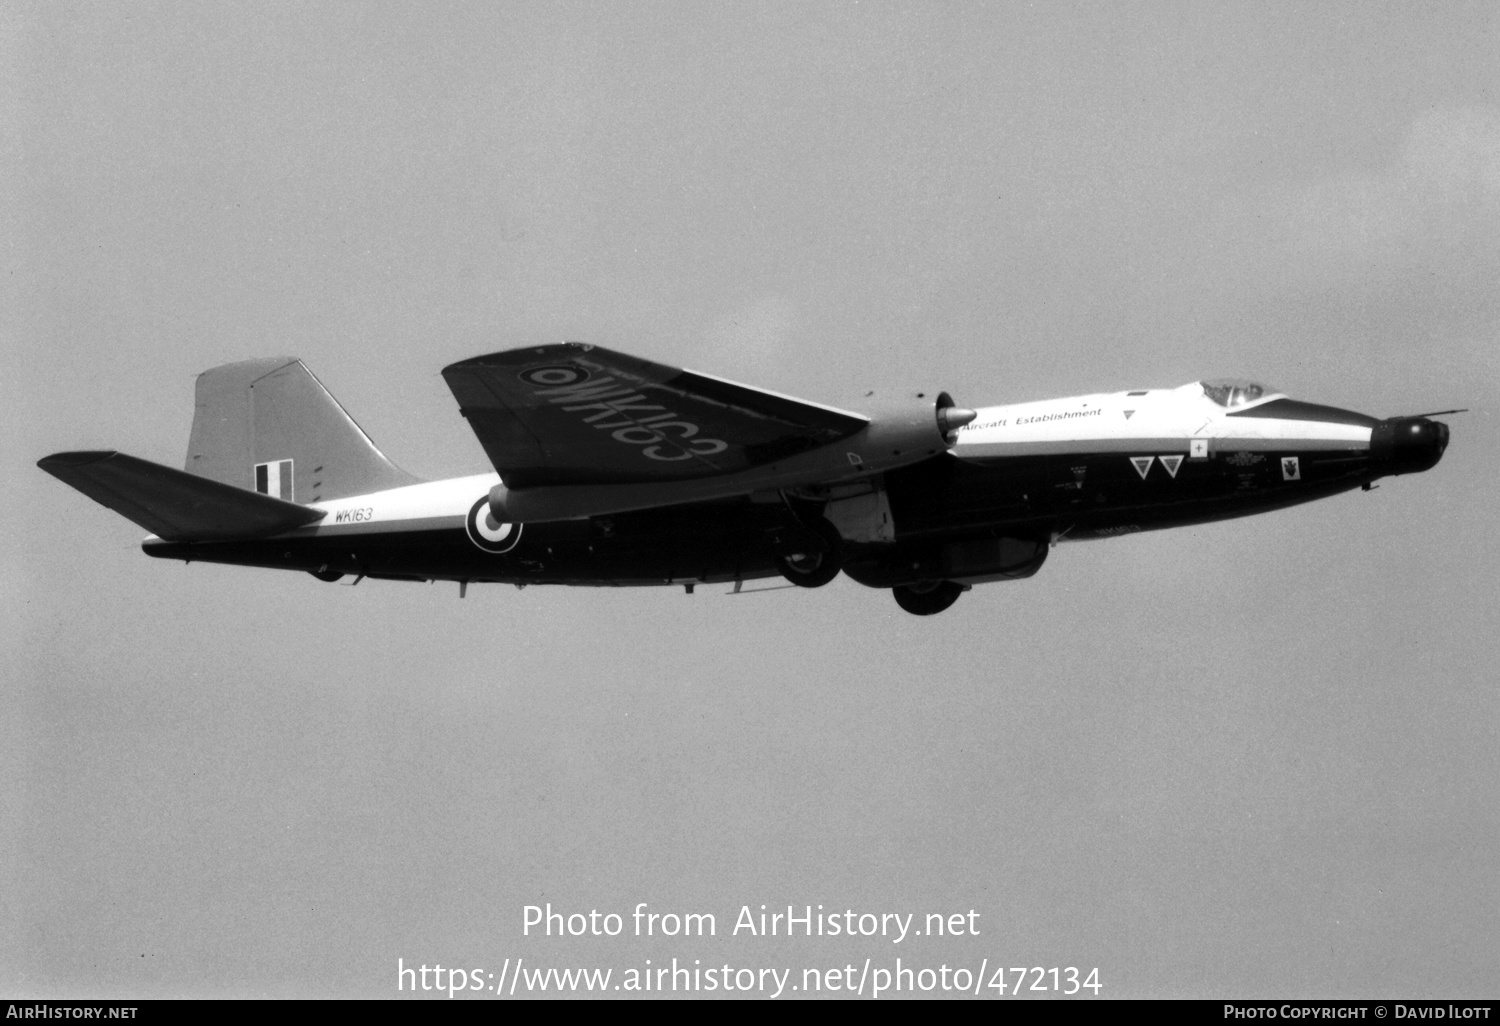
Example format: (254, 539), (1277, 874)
(0, 2), (1500, 998)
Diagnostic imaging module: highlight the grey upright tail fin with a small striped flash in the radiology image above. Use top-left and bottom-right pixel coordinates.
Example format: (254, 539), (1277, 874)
(186, 357), (420, 503)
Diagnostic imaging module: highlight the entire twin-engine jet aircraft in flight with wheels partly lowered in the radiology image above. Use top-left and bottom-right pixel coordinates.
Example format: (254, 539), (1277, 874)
(39, 344), (1458, 615)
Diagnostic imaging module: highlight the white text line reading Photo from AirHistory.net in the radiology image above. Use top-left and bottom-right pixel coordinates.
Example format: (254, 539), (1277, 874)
(521, 902), (981, 944)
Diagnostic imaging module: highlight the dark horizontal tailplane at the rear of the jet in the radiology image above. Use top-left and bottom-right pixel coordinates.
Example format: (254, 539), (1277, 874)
(36, 452), (324, 542)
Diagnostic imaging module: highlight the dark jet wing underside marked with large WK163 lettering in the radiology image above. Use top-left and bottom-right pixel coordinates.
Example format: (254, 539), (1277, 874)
(443, 342), (869, 489)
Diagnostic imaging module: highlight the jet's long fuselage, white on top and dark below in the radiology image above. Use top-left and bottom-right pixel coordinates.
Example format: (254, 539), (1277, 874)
(144, 383), (1448, 587)
